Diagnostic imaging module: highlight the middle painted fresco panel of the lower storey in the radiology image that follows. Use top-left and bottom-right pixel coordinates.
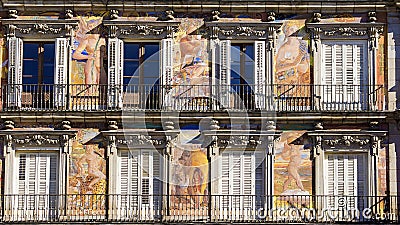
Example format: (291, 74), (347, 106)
(170, 130), (209, 216)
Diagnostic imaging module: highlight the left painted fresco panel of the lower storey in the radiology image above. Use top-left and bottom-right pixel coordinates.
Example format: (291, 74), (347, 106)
(68, 129), (107, 215)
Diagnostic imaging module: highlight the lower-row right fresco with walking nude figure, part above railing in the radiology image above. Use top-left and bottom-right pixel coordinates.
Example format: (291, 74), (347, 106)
(274, 131), (312, 196)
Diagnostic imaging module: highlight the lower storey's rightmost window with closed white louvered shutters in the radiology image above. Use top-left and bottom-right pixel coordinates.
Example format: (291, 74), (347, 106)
(324, 153), (368, 214)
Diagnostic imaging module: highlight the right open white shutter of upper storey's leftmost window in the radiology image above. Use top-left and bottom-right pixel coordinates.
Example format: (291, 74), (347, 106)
(54, 38), (69, 107)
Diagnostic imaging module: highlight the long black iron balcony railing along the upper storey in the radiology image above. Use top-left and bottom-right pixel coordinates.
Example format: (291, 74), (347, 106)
(2, 84), (386, 112)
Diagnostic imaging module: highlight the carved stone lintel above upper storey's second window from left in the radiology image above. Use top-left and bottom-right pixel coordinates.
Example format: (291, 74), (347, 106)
(103, 19), (179, 39)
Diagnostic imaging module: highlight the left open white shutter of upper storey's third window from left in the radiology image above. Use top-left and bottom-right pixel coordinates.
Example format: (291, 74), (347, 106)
(216, 40), (231, 108)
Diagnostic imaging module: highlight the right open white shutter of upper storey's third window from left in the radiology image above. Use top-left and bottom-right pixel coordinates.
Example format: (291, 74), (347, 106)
(254, 41), (266, 109)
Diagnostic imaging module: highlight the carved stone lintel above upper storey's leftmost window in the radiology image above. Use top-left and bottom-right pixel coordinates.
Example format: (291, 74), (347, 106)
(1, 19), (78, 38)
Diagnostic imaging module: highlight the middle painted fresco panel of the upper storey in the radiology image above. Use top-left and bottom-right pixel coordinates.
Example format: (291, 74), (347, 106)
(166, 18), (210, 109)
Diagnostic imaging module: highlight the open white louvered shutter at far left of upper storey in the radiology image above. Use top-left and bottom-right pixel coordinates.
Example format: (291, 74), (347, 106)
(7, 37), (23, 107)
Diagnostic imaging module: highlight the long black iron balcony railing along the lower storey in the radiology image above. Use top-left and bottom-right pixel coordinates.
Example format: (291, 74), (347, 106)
(0, 194), (399, 224)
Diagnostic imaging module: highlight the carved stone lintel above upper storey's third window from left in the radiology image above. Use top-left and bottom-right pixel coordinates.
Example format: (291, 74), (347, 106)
(206, 21), (282, 40)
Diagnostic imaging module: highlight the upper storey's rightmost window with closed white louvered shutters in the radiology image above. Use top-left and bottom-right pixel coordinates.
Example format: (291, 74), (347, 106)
(321, 41), (368, 109)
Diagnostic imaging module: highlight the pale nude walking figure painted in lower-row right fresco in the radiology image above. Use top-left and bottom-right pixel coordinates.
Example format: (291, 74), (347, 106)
(282, 142), (305, 191)
